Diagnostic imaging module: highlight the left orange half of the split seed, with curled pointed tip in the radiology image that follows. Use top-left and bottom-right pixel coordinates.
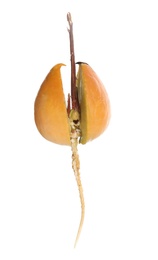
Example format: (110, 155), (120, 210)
(34, 64), (70, 145)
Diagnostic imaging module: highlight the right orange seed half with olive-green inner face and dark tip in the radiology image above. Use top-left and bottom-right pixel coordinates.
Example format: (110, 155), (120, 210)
(77, 63), (110, 144)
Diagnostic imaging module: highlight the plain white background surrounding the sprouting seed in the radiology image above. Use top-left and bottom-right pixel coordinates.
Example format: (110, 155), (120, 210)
(0, 0), (158, 260)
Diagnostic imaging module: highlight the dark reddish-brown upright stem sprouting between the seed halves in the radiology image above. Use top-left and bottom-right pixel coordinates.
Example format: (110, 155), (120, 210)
(67, 13), (79, 111)
